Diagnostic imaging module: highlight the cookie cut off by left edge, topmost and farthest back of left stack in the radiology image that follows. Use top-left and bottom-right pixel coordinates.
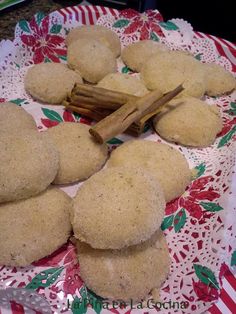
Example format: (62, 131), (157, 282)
(0, 102), (37, 133)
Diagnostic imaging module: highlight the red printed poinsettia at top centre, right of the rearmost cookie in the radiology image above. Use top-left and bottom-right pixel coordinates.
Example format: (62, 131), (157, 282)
(120, 9), (164, 40)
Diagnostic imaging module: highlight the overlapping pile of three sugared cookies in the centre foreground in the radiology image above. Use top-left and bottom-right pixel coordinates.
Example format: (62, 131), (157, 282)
(72, 140), (191, 301)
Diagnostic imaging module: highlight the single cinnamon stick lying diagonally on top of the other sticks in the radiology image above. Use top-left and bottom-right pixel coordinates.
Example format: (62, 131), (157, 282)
(89, 85), (183, 144)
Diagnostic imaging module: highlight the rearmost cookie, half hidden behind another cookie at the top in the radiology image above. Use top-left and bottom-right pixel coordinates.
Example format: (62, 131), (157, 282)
(66, 25), (121, 57)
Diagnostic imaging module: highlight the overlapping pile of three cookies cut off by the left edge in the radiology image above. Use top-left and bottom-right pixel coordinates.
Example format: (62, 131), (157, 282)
(0, 103), (71, 266)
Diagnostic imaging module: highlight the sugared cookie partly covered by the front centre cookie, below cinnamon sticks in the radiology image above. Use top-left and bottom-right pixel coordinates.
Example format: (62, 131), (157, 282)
(107, 140), (191, 202)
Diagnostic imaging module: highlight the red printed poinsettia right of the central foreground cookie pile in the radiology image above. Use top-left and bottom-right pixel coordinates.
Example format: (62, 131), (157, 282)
(166, 176), (220, 219)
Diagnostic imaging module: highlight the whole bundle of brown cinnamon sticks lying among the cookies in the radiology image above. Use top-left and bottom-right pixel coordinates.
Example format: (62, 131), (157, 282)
(63, 84), (183, 143)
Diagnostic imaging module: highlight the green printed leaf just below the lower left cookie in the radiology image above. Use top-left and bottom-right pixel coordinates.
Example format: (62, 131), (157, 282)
(25, 267), (63, 290)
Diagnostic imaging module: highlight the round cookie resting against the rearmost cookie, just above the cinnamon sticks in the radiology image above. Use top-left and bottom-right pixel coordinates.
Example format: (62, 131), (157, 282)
(67, 38), (117, 83)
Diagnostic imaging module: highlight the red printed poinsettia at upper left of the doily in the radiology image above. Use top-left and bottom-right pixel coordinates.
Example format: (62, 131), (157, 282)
(21, 16), (66, 63)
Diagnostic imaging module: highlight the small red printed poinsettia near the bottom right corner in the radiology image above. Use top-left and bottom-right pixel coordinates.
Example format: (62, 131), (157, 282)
(193, 280), (219, 302)
